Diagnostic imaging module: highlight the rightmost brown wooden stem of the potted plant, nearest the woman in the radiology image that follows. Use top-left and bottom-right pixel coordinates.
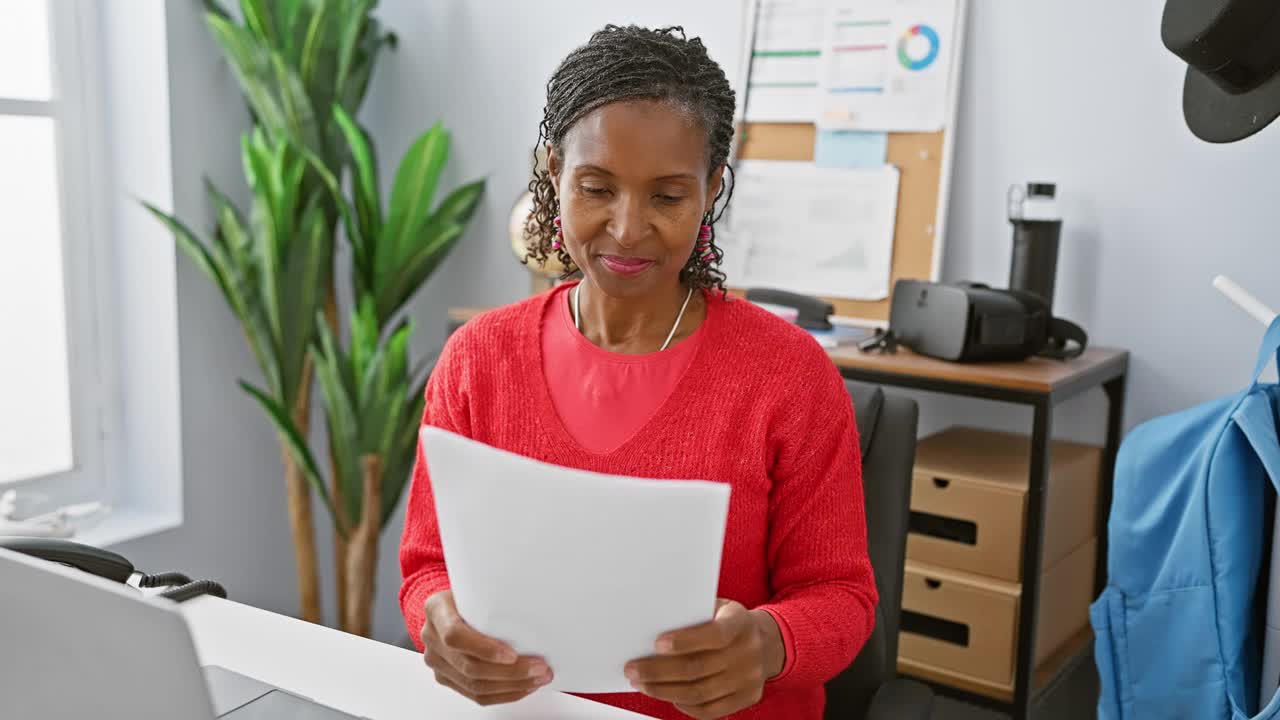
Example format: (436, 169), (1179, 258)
(344, 455), (383, 637)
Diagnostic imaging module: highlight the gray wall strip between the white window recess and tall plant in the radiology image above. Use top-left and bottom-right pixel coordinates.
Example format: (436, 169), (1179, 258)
(104, 0), (297, 614)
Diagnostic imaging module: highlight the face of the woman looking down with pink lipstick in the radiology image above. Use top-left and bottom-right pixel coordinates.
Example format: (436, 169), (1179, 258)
(548, 100), (724, 297)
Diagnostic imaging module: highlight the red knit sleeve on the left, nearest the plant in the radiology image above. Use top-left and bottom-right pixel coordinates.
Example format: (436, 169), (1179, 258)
(399, 332), (470, 650)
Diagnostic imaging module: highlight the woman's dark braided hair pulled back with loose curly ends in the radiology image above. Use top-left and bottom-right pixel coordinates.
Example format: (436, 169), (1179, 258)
(525, 24), (735, 292)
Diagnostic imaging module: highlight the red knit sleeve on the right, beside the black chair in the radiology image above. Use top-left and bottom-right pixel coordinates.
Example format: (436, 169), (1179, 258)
(759, 356), (878, 687)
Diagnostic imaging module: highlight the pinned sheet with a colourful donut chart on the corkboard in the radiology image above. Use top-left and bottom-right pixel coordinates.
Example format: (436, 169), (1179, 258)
(818, 0), (956, 132)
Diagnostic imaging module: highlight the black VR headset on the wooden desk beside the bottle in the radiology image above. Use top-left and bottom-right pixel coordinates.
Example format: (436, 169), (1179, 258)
(890, 281), (1088, 363)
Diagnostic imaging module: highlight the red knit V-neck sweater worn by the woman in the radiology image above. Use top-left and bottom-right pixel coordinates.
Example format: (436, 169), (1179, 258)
(401, 286), (877, 720)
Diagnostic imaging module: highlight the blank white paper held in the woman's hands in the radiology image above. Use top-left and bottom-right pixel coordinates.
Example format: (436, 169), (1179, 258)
(421, 428), (730, 693)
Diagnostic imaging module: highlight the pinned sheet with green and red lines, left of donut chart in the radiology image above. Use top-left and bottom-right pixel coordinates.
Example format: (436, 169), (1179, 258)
(746, 0), (827, 123)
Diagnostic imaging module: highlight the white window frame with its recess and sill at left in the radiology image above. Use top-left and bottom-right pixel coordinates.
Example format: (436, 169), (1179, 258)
(0, 0), (183, 546)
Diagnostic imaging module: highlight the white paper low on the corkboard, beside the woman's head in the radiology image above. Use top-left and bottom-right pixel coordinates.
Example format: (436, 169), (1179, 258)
(717, 160), (899, 300)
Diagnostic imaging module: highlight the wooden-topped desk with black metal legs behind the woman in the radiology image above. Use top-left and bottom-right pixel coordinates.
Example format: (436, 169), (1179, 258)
(449, 307), (1129, 720)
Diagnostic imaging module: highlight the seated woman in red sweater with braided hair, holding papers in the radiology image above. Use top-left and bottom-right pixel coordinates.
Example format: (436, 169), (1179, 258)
(401, 26), (877, 720)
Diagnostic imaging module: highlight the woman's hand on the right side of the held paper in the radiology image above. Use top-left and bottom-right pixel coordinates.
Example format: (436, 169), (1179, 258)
(626, 600), (786, 720)
